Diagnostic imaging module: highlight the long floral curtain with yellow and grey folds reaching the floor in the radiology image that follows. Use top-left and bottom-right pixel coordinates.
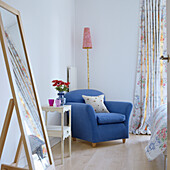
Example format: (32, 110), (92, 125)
(130, 0), (167, 134)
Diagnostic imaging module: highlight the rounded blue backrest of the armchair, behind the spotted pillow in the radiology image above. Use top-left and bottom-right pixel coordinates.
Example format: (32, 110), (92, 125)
(65, 89), (103, 103)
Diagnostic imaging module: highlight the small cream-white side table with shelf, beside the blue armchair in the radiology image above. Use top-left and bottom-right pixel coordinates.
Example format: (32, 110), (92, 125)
(42, 105), (71, 164)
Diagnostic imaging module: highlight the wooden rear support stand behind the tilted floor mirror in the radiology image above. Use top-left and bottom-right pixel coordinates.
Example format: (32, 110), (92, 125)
(0, 99), (29, 170)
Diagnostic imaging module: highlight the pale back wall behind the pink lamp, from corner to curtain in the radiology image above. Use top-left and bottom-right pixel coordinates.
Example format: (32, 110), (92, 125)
(75, 0), (140, 101)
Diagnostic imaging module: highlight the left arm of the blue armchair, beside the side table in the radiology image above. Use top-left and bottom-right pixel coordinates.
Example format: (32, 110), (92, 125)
(66, 102), (98, 142)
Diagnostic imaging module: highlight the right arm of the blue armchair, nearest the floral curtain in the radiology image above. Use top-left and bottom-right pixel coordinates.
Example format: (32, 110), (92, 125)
(105, 101), (133, 123)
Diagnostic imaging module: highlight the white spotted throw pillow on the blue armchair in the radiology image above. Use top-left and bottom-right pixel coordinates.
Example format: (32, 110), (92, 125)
(82, 95), (109, 113)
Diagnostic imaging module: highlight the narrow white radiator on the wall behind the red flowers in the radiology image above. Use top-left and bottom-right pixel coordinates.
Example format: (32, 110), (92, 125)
(67, 66), (77, 91)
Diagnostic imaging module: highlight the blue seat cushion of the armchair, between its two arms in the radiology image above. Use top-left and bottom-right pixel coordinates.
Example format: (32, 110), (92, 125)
(96, 113), (126, 125)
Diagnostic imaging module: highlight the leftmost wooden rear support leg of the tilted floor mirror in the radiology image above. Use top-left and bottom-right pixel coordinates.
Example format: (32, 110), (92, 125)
(0, 99), (14, 159)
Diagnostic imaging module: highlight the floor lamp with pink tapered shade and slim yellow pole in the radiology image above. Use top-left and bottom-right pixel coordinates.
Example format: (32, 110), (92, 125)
(83, 27), (92, 89)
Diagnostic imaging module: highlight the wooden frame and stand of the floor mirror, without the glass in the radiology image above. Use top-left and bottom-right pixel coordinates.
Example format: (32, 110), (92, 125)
(0, 0), (55, 170)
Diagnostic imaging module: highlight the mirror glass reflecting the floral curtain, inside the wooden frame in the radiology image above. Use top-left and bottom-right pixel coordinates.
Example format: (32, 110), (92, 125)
(0, 8), (50, 170)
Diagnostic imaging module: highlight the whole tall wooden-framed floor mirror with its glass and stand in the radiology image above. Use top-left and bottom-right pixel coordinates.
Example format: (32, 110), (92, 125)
(0, 0), (55, 170)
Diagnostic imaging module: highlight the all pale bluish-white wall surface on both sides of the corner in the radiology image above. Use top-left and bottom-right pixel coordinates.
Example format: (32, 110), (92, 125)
(0, 0), (139, 166)
